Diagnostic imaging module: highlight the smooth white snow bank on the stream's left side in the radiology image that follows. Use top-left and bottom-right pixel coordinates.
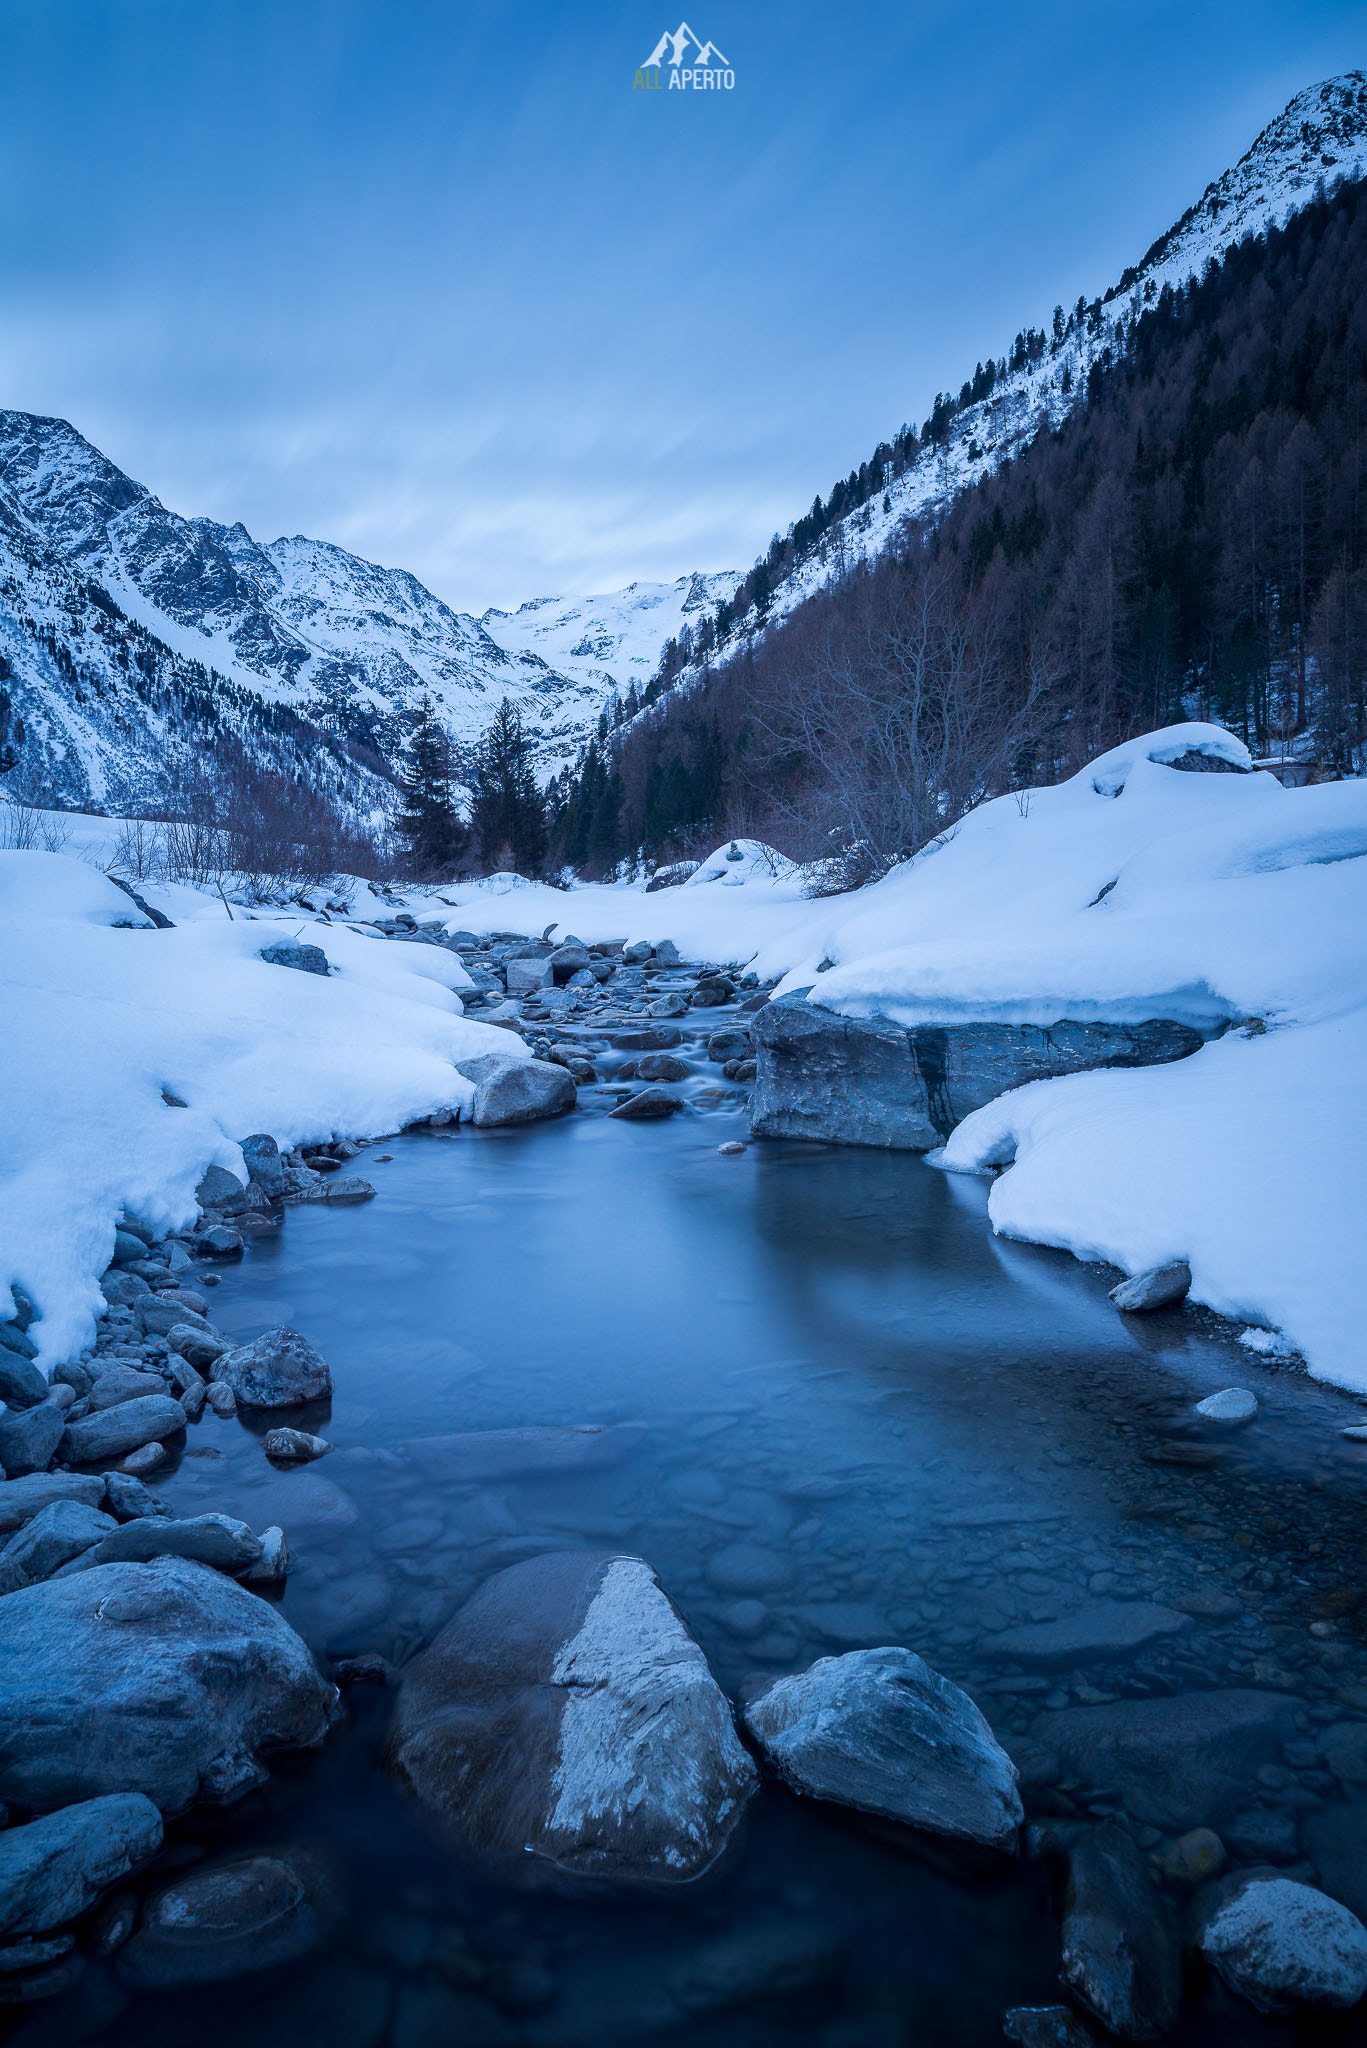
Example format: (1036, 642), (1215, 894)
(0, 852), (525, 1364)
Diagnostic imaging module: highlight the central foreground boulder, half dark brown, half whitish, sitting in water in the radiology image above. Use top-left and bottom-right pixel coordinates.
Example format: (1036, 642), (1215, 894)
(389, 1550), (758, 1886)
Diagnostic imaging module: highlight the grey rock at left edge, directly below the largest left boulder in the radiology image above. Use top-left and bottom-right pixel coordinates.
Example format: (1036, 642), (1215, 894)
(0, 1792), (162, 1935)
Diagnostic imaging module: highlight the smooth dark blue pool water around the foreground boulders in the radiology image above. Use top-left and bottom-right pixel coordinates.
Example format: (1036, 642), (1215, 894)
(42, 1032), (1367, 2048)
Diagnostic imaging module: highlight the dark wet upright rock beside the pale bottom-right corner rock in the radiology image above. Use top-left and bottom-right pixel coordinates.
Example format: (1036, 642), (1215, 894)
(1060, 1827), (1183, 2042)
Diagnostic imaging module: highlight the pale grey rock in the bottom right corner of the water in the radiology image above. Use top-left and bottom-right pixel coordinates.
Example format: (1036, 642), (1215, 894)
(1188, 1875), (1367, 2013)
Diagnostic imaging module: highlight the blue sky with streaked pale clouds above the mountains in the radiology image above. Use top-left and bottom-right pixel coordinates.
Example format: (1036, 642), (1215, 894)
(0, 0), (1367, 610)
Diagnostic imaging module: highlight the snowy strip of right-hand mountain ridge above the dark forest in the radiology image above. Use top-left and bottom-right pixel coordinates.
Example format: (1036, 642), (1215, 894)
(680, 72), (1367, 686)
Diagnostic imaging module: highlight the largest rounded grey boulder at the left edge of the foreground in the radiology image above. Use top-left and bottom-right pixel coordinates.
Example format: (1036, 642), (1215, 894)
(0, 1556), (334, 1812)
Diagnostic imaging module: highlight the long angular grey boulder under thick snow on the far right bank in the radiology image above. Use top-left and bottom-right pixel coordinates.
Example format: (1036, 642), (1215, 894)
(750, 995), (1203, 1151)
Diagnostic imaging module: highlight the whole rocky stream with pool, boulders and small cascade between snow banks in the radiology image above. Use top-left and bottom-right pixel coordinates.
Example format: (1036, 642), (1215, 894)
(0, 926), (1367, 2048)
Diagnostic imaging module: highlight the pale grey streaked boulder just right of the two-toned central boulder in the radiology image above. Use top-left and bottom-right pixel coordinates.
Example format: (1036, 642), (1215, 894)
(744, 1649), (1025, 1849)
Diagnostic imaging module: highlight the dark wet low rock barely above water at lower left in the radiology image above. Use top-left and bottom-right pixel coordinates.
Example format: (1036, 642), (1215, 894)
(119, 1849), (336, 1989)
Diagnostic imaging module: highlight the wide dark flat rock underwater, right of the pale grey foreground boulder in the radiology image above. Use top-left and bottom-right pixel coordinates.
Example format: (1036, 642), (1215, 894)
(1017, 1688), (1297, 1835)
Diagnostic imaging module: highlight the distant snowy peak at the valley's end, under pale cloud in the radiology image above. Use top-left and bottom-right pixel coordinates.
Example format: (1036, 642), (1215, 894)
(480, 569), (740, 698)
